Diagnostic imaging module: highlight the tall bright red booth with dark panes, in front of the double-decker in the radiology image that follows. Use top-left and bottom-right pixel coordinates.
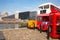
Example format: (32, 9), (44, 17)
(48, 12), (60, 40)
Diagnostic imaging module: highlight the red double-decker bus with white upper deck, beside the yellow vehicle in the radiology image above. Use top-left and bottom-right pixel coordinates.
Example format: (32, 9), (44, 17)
(36, 3), (60, 32)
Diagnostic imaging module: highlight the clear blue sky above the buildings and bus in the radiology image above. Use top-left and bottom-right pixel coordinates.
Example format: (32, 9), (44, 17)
(0, 0), (60, 14)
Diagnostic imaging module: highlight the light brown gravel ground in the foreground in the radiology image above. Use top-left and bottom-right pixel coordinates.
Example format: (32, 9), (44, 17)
(2, 28), (57, 40)
